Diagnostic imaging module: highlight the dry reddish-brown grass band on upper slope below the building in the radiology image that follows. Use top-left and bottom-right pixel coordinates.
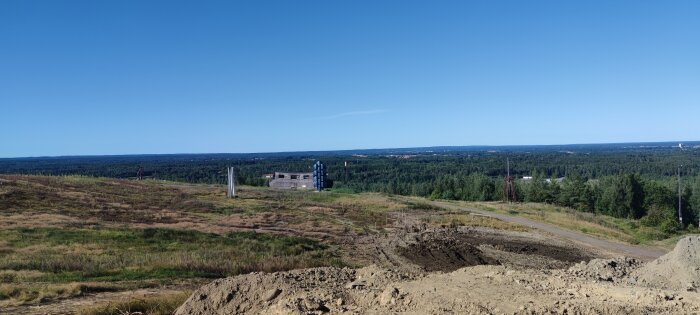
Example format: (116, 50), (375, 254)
(0, 175), (405, 236)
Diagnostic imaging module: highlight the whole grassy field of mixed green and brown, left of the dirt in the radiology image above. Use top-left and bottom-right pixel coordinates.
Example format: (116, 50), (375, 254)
(0, 175), (435, 314)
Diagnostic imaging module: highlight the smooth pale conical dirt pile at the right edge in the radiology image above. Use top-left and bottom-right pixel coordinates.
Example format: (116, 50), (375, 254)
(633, 236), (700, 291)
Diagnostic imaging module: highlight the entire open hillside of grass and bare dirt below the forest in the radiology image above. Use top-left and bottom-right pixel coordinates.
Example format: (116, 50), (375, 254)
(0, 172), (700, 315)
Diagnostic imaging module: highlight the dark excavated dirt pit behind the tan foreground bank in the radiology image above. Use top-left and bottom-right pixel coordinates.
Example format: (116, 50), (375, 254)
(397, 230), (595, 272)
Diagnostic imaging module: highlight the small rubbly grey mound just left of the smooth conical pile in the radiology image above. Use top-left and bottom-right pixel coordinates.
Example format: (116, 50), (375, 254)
(568, 257), (642, 283)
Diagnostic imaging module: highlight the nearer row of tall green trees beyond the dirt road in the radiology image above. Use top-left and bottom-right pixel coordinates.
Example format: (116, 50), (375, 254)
(429, 171), (700, 233)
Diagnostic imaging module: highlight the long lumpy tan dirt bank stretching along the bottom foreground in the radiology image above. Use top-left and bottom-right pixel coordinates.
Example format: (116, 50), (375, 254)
(175, 265), (700, 315)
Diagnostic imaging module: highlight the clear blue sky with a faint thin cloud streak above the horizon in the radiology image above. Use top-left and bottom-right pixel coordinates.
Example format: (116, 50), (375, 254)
(0, 0), (700, 157)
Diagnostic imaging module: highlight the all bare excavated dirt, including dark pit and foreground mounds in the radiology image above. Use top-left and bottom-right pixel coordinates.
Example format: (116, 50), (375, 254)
(176, 226), (700, 315)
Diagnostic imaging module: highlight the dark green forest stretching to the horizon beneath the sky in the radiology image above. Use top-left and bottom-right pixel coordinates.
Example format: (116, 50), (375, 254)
(0, 143), (700, 233)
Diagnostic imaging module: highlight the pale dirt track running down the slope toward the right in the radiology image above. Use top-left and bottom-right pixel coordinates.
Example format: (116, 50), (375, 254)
(432, 201), (666, 261)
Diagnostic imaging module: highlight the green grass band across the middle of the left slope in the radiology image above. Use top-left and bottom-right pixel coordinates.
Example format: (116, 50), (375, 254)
(0, 228), (344, 283)
